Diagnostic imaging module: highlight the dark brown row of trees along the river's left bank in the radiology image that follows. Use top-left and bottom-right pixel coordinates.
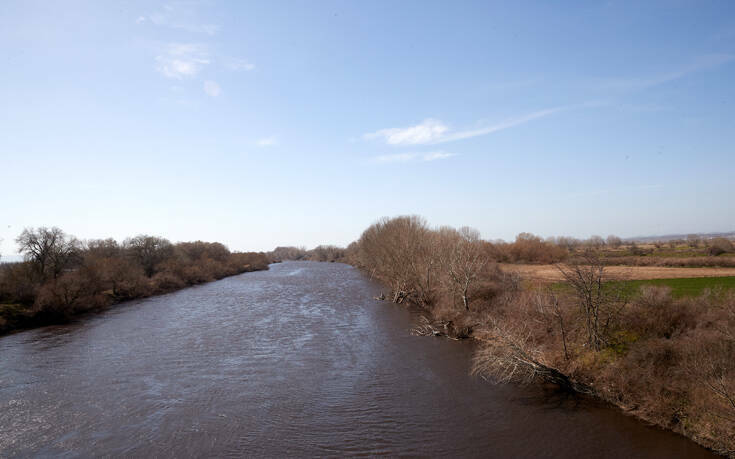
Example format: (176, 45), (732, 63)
(0, 227), (269, 333)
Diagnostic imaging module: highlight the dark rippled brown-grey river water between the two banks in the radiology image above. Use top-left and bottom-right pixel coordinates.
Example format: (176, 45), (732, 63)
(0, 262), (711, 458)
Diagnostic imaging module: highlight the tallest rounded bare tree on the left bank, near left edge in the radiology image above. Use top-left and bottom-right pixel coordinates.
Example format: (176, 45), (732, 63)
(15, 227), (80, 280)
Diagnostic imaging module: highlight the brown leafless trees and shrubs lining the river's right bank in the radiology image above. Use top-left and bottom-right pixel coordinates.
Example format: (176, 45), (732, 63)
(344, 216), (735, 454)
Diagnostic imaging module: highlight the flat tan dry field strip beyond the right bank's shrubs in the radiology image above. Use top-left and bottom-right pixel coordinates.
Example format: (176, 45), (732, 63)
(500, 263), (735, 282)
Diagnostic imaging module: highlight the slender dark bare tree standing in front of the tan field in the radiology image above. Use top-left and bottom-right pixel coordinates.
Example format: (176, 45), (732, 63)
(557, 252), (627, 351)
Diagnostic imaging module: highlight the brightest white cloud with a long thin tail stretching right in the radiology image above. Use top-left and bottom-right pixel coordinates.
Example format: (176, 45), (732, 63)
(363, 106), (573, 145)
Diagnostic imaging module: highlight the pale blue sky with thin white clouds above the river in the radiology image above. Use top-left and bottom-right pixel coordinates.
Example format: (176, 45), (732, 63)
(0, 0), (735, 255)
